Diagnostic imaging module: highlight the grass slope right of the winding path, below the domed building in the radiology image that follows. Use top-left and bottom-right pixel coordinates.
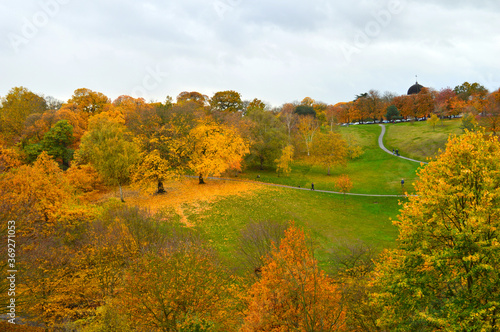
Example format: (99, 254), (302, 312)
(384, 119), (463, 161)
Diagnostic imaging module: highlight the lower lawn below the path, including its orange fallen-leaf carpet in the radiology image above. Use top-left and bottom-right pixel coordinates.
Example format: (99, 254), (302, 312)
(127, 179), (400, 270)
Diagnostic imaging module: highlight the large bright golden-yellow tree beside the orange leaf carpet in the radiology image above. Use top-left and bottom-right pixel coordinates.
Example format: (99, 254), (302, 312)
(187, 122), (249, 184)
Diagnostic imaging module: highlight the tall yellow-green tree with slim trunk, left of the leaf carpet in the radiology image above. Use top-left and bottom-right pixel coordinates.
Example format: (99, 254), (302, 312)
(77, 113), (139, 201)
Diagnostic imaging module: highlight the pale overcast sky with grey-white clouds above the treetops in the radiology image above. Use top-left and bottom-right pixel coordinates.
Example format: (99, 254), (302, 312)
(0, 0), (500, 106)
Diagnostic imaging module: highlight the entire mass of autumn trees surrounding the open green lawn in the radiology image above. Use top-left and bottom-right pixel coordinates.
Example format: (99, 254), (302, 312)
(0, 83), (500, 331)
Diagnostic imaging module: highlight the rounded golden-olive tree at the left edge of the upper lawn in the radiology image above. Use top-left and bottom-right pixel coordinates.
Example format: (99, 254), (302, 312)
(311, 131), (347, 175)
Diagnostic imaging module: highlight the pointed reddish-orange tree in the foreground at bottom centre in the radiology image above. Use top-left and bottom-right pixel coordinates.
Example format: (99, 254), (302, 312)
(242, 224), (345, 331)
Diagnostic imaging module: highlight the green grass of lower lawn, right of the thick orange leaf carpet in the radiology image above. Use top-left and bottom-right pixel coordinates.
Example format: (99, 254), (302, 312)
(182, 187), (400, 270)
